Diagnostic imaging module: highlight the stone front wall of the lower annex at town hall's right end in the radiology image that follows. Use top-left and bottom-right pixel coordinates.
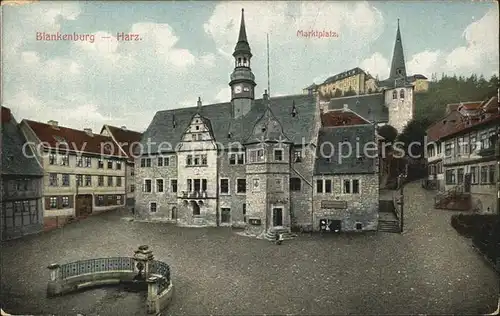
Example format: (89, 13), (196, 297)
(313, 174), (379, 231)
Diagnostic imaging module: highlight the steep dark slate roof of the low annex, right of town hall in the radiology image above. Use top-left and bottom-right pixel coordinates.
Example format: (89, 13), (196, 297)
(314, 124), (377, 175)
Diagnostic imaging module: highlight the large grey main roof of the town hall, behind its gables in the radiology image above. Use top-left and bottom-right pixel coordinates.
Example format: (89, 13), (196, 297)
(141, 94), (316, 154)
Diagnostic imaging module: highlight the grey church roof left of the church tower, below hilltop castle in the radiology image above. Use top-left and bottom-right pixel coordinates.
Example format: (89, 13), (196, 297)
(328, 93), (389, 123)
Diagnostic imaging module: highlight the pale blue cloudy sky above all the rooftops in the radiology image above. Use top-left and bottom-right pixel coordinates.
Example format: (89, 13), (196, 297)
(2, 1), (499, 131)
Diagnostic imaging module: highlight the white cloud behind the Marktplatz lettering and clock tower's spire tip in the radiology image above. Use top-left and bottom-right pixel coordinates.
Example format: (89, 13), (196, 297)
(204, 1), (383, 56)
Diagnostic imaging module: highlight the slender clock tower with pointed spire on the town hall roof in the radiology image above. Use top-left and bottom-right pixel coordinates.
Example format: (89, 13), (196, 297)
(229, 9), (257, 118)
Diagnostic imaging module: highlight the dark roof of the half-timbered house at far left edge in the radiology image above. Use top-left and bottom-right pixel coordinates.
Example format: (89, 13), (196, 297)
(0, 106), (43, 176)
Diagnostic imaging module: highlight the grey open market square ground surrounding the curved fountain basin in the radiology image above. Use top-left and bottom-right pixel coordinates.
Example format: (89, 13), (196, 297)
(1, 183), (498, 316)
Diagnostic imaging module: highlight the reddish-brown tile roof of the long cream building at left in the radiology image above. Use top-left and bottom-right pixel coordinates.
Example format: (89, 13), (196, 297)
(23, 120), (125, 158)
